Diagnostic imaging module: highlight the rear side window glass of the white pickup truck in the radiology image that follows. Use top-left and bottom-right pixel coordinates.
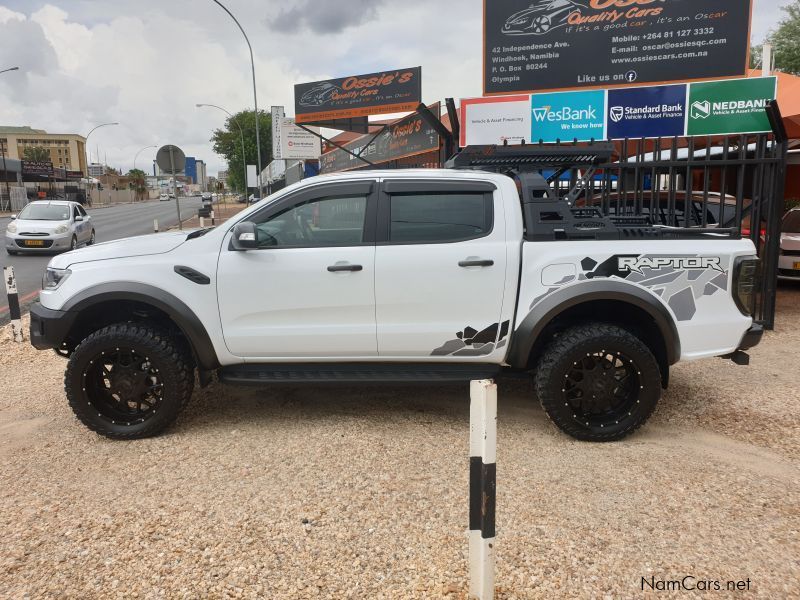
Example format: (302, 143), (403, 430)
(389, 192), (492, 244)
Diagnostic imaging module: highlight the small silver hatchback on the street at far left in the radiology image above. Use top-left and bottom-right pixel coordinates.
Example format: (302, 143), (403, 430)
(6, 200), (95, 255)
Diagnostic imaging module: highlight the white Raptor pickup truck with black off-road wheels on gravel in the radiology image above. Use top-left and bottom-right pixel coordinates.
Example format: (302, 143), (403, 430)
(26, 149), (763, 441)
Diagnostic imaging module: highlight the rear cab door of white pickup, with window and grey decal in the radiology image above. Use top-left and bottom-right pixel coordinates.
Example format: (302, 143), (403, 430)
(375, 179), (506, 362)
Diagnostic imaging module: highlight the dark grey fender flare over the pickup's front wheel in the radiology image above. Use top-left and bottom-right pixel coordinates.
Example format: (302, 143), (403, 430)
(61, 281), (220, 370)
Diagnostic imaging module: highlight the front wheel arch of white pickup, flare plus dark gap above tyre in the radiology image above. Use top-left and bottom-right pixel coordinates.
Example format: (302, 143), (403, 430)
(62, 282), (220, 370)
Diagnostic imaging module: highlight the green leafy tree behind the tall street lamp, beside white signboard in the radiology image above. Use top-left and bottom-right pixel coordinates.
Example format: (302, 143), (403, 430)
(211, 110), (272, 192)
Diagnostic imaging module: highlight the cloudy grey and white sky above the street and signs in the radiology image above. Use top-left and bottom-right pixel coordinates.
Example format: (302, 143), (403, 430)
(0, 0), (788, 175)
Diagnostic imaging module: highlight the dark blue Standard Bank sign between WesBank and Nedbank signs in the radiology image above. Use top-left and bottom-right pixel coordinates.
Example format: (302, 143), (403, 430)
(607, 85), (686, 140)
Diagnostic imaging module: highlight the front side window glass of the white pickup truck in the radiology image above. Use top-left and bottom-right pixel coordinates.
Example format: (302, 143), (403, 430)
(256, 196), (367, 248)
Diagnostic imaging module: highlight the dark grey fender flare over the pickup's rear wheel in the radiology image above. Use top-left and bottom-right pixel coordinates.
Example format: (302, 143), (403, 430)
(507, 279), (681, 369)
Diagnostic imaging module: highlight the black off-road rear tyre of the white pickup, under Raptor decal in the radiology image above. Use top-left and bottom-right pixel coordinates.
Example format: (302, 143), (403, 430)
(534, 322), (662, 442)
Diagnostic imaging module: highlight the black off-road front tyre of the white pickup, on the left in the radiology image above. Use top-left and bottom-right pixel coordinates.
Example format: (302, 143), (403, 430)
(64, 323), (195, 440)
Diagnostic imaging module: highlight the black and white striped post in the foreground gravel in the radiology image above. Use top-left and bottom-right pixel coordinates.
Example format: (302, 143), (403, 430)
(469, 380), (497, 600)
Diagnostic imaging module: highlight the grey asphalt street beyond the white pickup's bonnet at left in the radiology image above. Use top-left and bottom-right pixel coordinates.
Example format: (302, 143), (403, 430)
(0, 196), (201, 325)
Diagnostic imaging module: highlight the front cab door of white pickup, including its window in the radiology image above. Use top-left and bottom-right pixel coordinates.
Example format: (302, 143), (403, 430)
(217, 180), (378, 360)
